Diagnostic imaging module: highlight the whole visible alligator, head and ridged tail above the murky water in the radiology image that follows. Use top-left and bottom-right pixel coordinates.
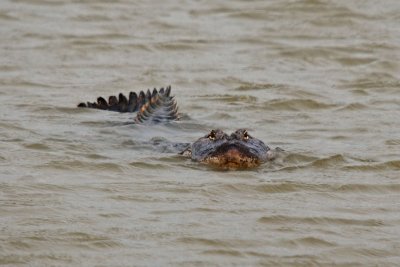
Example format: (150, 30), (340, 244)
(78, 86), (280, 169)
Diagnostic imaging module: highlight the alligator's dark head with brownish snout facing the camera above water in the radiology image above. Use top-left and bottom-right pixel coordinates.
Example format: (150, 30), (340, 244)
(183, 129), (271, 169)
